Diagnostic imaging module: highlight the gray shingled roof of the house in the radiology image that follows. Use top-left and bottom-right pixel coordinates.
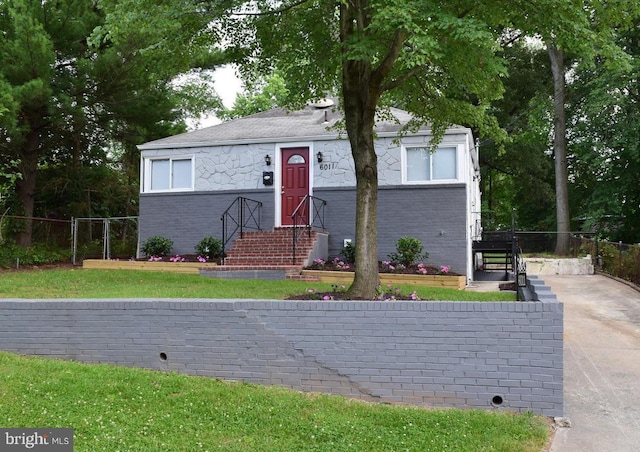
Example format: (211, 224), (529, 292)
(138, 100), (438, 150)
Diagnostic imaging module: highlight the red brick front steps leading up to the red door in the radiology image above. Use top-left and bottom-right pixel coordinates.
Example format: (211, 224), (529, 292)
(200, 228), (328, 281)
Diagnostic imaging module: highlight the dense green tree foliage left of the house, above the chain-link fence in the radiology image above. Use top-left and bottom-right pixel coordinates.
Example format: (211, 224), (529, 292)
(0, 0), (218, 245)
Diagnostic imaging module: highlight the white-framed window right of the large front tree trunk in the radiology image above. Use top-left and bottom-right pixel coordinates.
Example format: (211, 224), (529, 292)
(404, 146), (458, 184)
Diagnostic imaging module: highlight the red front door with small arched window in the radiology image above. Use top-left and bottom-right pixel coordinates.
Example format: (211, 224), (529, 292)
(281, 147), (309, 226)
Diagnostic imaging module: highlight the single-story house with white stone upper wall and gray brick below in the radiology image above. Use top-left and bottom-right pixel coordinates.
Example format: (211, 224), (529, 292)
(138, 101), (480, 279)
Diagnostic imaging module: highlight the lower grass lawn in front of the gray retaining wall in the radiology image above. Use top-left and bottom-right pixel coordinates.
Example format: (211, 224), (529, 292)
(0, 352), (549, 452)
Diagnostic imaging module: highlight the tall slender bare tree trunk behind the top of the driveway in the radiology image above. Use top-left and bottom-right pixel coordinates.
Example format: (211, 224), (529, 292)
(547, 44), (571, 256)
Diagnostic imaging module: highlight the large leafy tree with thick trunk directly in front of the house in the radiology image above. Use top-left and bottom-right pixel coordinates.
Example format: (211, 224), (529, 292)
(228, 0), (596, 298)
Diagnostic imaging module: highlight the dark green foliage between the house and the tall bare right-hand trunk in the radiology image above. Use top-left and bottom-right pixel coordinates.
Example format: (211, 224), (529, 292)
(479, 39), (555, 231)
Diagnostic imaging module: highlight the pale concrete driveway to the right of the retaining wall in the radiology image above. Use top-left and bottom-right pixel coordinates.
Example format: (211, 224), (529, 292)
(541, 275), (640, 452)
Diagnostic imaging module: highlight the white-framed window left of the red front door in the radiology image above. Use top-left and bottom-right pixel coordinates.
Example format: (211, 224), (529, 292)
(144, 157), (193, 192)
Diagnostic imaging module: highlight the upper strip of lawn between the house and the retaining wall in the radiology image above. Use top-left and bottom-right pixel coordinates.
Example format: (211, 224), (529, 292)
(0, 269), (515, 301)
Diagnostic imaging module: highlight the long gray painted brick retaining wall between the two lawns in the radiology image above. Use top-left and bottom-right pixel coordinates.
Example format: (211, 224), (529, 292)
(0, 299), (563, 416)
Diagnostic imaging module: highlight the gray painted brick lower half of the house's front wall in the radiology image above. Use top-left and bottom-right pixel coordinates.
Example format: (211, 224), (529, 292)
(139, 184), (467, 277)
